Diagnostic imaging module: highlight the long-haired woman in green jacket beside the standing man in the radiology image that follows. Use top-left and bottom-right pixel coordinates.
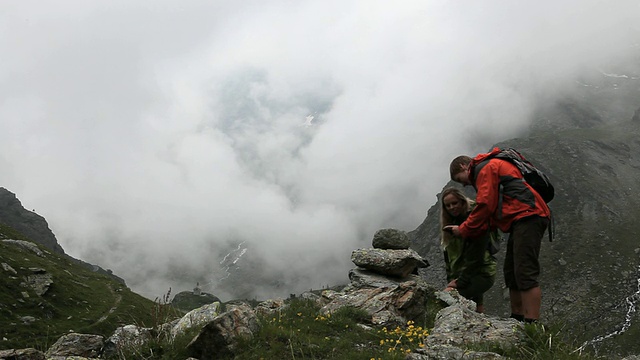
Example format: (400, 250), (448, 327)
(440, 188), (497, 313)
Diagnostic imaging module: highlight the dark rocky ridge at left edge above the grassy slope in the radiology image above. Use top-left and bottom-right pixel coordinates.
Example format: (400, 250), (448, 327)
(0, 187), (64, 254)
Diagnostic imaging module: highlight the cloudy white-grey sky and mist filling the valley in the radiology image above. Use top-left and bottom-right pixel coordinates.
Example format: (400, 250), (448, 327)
(0, 0), (640, 298)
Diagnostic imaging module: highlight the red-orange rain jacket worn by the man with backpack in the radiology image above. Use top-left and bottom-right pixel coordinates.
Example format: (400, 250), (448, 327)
(460, 147), (551, 238)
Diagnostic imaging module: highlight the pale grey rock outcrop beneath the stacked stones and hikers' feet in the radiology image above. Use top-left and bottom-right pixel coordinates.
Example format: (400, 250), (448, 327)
(321, 233), (525, 360)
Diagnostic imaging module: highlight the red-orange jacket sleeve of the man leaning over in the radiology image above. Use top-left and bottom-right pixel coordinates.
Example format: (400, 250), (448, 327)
(459, 160), (500, 238)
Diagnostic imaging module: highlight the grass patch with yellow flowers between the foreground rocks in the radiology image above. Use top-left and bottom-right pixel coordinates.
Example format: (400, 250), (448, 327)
(235, 299), (427, 359)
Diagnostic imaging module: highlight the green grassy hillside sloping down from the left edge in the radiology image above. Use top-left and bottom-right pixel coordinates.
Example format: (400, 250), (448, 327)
(0, 224), (157, 350)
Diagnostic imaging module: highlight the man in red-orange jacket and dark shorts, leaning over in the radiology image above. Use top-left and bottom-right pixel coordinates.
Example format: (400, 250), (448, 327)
(445, 148), (551, 322)
